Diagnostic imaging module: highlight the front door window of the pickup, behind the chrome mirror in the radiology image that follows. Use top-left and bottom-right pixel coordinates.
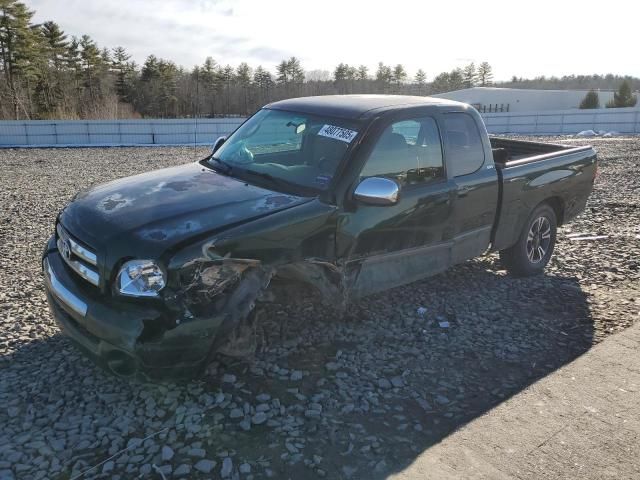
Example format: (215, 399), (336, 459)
(360, 117), (445, 184)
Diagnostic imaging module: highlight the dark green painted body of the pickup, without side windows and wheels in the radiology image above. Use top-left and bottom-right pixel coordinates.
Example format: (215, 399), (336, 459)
(43, 96), (595, 378)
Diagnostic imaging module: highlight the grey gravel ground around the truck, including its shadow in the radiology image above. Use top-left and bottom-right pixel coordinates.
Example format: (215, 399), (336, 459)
(0, 138), (640, 479)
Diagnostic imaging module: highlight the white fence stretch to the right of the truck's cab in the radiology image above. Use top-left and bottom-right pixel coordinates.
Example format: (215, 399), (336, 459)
(482, 108), (640, 135)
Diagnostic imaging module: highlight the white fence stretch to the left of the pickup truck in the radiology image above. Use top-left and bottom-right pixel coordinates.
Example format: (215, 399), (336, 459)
(0, 117), (244, 147)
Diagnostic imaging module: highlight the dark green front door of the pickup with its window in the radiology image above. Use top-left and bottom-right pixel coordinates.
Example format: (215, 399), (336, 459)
(337, 116), (456, 297)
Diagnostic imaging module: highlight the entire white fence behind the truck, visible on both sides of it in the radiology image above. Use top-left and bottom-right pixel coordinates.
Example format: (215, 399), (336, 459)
(0, 108), (640, 147)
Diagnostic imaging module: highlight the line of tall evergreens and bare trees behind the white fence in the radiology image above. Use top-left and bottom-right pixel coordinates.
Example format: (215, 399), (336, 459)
(0, 0), (640, 119)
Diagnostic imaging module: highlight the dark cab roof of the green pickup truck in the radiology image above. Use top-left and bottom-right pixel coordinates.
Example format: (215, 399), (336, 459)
(265, 95), (466, 120)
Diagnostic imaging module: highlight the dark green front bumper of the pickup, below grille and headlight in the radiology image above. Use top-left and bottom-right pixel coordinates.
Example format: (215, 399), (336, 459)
(42, 237), (219, 379)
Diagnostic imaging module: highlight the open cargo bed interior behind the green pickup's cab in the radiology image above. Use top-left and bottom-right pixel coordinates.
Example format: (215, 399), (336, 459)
(489, 136), (591, 168)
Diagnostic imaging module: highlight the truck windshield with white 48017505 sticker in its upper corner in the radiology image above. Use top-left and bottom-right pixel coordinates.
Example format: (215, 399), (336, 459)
(213, 109), (358, 190)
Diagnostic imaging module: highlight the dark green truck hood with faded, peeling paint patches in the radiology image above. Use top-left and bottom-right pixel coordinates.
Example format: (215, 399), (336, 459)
(60, 163), (310, 256)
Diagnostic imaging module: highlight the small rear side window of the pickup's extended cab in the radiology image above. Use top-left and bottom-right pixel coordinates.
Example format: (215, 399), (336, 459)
(444, 113), (484, 177)
